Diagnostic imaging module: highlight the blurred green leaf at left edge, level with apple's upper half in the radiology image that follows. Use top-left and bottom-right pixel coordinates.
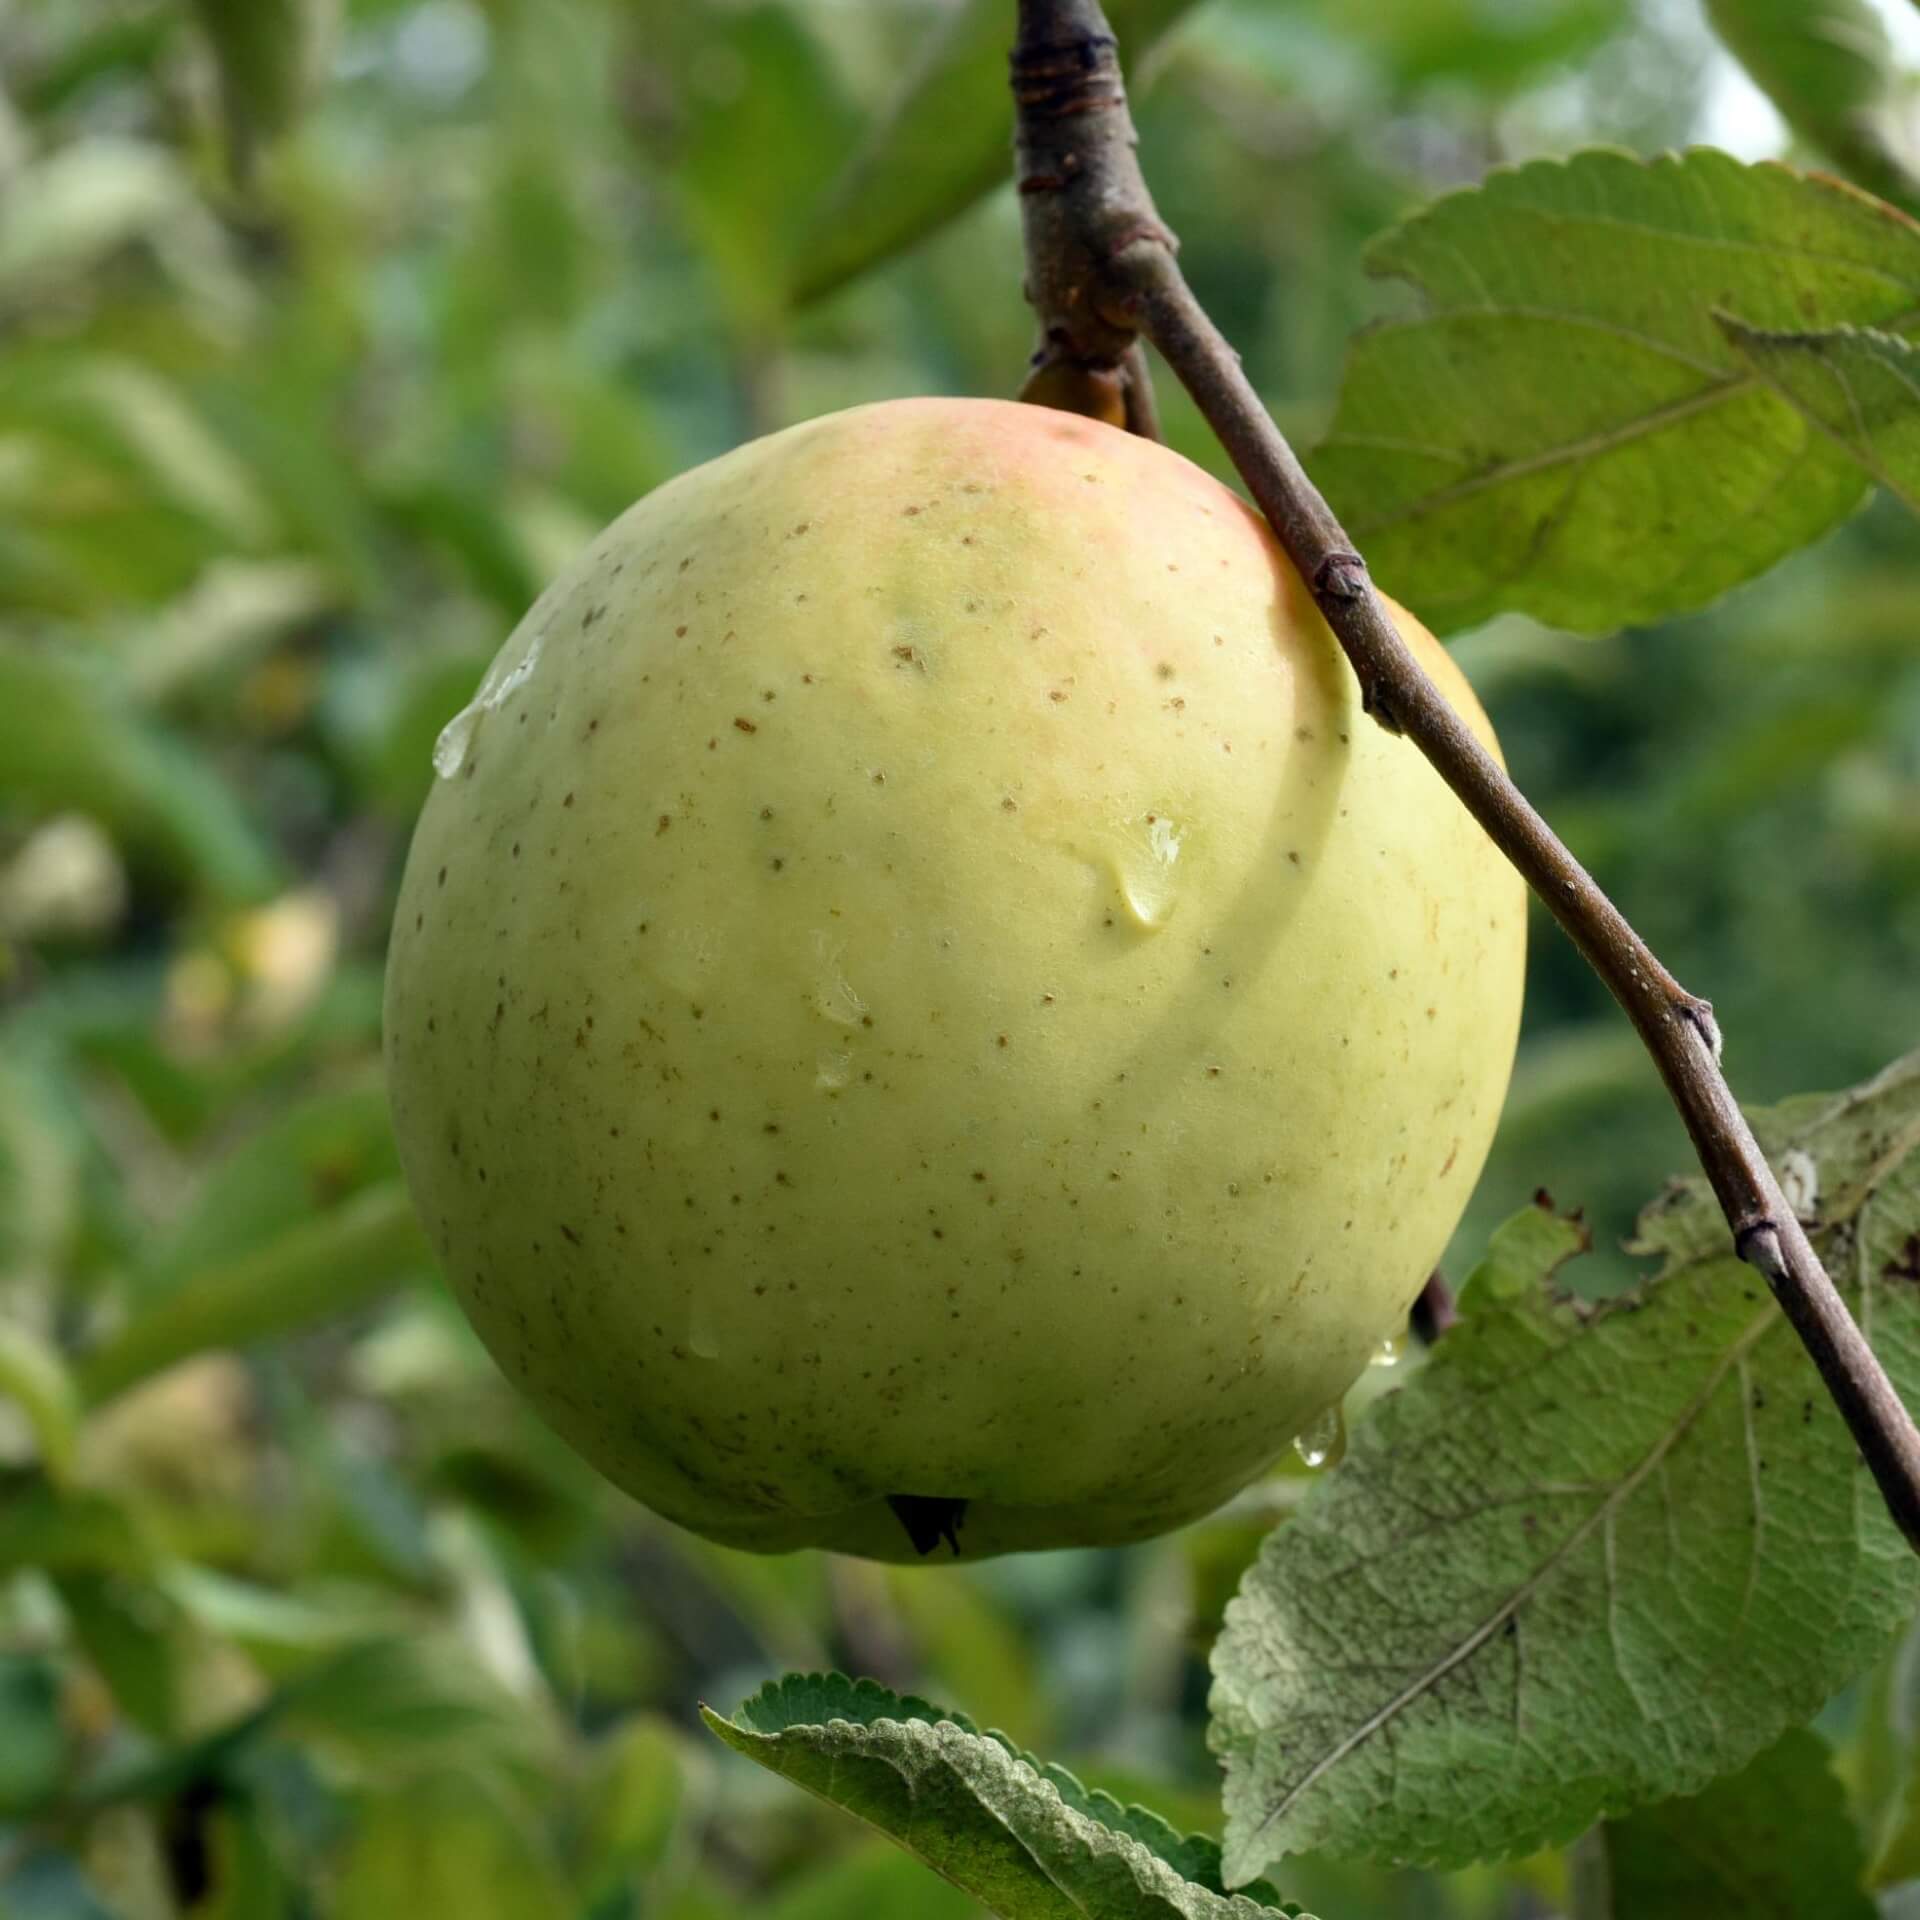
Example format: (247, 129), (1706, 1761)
(0, 645), (280, 900)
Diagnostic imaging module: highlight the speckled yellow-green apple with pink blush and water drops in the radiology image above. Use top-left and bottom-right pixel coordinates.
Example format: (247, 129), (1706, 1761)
(386, 399), (1524, 1559)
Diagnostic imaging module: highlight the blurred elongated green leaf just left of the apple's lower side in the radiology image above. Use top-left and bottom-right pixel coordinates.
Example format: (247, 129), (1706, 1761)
(81, 1181), (434, 1405)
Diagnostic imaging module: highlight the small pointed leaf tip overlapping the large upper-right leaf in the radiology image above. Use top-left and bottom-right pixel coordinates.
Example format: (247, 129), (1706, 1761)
(1720, 321), (1920, 513)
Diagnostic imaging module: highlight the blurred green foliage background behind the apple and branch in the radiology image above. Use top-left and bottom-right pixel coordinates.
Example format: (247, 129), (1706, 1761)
(0, 0), (1920, 1920)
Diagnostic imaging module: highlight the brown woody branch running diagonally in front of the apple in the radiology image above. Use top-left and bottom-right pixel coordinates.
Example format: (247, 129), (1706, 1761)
(1012, 0), (1920, 1549)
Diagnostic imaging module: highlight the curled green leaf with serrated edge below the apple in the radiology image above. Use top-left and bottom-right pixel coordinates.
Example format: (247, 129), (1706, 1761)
(701, 1674), (1290, 1920)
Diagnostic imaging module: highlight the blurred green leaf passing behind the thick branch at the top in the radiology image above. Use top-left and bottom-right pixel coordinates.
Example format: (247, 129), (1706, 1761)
(791, 0), (1192, 305)
